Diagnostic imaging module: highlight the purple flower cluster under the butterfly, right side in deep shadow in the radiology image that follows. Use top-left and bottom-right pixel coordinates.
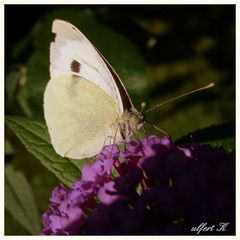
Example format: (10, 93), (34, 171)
(42, 136), (235, 235)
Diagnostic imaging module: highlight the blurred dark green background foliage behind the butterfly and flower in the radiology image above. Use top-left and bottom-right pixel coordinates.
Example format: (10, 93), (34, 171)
(5, 5), (235, 235)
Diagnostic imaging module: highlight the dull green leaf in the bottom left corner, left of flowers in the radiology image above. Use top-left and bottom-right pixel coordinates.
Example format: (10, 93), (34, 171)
(5, 165), (40, 235)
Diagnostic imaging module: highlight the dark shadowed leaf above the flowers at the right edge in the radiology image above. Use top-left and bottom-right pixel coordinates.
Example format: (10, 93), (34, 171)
(176, 121), (235, 152)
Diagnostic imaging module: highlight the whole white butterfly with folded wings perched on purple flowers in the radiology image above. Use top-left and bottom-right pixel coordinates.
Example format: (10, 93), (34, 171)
(44, 20), (144, 159)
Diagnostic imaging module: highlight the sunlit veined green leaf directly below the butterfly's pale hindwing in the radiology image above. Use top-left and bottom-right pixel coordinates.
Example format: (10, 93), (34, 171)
(6, 116), (80, 186)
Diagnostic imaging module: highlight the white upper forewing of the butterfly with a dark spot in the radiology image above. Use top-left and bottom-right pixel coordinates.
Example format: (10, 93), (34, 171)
(50, 19), (132, 113)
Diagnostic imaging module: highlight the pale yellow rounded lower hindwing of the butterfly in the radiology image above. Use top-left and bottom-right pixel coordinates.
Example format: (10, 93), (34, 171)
(44, 74), (121, 159)
